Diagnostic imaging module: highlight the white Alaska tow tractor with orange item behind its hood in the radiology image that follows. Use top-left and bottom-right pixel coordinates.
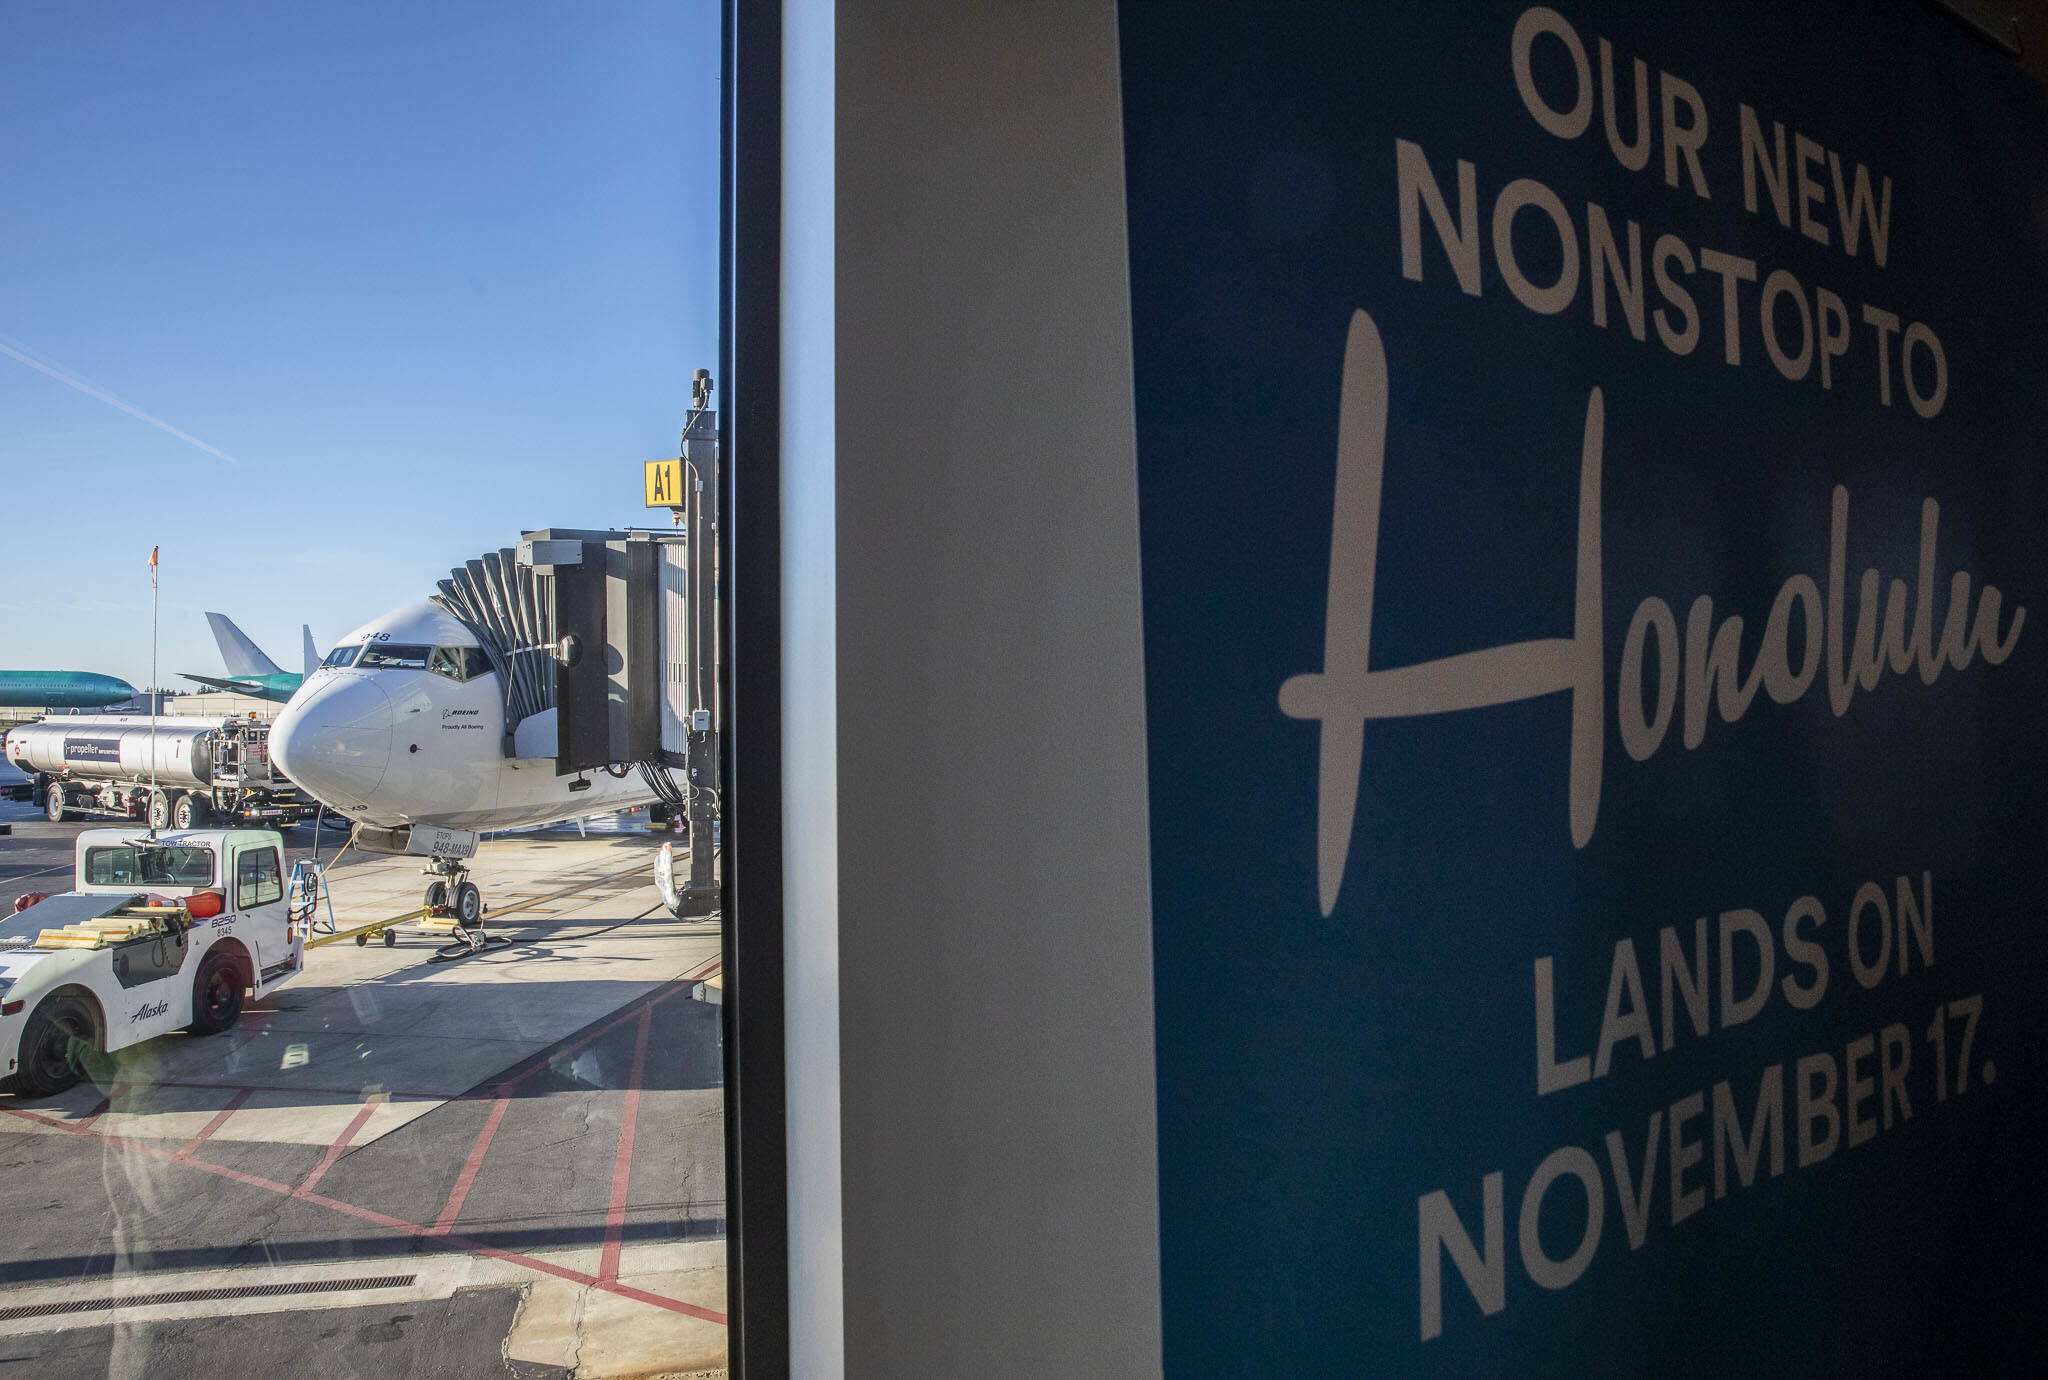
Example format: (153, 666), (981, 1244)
(0, 829), (305, 1097)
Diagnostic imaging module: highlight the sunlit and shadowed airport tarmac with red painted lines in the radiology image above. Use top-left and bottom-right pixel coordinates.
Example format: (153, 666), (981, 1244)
(0, 806), (725, 1378)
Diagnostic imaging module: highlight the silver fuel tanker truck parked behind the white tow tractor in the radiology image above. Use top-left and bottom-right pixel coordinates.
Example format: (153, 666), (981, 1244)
(6, 715), (317, 829)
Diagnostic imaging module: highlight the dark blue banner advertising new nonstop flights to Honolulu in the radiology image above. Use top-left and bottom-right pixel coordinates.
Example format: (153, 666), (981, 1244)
(1118, 0), (2048, 1376)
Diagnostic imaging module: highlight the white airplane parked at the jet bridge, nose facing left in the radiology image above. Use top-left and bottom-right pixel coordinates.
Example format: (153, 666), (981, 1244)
(270, 602), (662, 950)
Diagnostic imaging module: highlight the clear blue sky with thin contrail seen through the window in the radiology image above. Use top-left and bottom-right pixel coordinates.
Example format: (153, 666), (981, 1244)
(0, 0), (719, 686)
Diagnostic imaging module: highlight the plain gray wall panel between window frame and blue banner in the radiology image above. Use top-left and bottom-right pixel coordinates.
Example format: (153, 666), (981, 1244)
(836, 0), (1159, 1376)
